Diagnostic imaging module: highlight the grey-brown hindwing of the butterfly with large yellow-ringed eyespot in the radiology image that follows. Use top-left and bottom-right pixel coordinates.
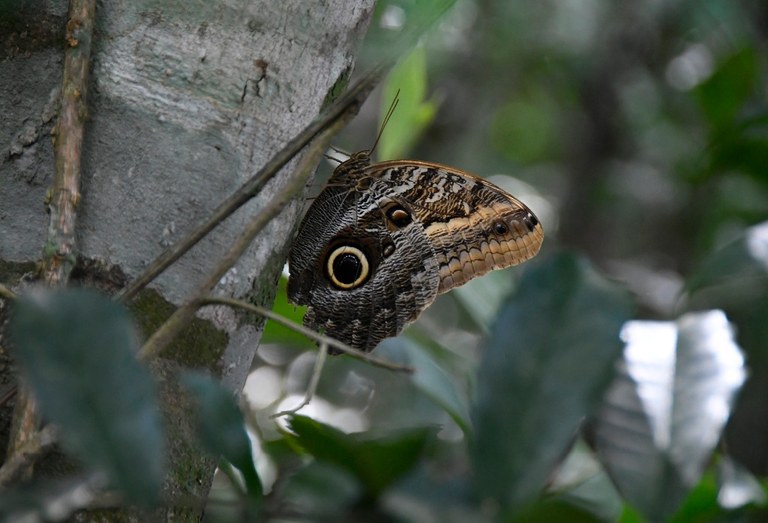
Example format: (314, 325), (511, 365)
(288, 180), (439, 351)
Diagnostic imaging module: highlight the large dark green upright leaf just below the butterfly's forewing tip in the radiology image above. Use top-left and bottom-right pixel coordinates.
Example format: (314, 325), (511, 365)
(471, 254), (631, 510)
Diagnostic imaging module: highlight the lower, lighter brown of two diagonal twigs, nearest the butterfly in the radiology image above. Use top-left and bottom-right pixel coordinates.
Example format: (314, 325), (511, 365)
(139, 110), (353, 359)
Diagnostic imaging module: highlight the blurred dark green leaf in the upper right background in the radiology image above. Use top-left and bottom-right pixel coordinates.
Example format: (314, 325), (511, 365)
(694, 47), (758, 129)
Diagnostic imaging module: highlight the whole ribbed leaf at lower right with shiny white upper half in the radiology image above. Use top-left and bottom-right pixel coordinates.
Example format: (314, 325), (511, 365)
(596, 311), (745, 521)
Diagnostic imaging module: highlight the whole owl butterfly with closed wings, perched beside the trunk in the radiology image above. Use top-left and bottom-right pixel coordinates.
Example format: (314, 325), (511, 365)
(288, 102), (544, 351)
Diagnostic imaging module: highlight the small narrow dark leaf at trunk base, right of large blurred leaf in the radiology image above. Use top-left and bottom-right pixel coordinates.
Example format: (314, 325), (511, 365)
(181, 372), (264, 499)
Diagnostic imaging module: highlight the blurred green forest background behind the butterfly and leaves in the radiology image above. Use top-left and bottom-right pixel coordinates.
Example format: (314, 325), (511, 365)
(231, 0), (768, 520)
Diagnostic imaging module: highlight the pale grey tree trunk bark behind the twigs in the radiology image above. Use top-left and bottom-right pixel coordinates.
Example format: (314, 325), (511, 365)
(0, 0), (373, 521)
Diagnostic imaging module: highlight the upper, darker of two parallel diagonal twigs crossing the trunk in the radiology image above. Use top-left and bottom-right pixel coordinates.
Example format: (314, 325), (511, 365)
(117, 64), (390, 301)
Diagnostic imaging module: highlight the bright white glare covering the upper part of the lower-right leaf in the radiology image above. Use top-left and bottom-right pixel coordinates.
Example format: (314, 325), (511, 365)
(621, 310), (746, 458)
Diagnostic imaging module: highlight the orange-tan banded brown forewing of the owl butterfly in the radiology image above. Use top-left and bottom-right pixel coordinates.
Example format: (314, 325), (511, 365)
(363, 160), (544, 293)
